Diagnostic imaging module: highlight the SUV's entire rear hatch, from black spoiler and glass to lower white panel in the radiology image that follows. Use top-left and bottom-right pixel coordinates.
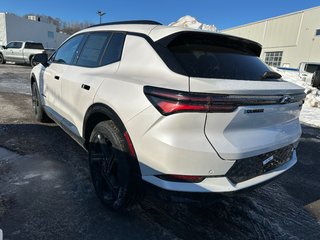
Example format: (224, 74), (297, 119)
(160, 32), (305, 160)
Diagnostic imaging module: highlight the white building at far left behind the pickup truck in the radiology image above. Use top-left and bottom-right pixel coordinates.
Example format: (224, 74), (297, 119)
(0, 13), (69, 48)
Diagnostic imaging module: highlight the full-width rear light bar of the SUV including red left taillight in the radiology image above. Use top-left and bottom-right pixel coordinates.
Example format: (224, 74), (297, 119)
(144, 86), (305, 116)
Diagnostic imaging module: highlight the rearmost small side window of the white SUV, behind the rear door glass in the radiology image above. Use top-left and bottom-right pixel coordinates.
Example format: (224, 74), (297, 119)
(101, 33), (125, 65)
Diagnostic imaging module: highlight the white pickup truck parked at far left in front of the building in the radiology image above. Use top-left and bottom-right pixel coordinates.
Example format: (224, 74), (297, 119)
(0, 41), (45, 67)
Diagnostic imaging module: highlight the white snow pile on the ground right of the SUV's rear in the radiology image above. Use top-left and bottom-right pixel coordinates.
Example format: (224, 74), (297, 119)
(274, 68), (320, 108)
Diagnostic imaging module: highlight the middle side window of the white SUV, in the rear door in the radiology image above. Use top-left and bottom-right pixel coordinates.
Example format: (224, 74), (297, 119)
(77, 32), (112, 67)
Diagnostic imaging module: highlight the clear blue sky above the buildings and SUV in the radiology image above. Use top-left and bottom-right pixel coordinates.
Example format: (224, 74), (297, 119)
(0, 0), (320, 30)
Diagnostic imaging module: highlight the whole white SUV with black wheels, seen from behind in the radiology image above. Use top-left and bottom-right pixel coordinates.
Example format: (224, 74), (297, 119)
(31, 21), (305, 209)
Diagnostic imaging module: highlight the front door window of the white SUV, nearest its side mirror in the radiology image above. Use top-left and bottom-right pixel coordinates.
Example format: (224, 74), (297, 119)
(51, 34), (84, 64)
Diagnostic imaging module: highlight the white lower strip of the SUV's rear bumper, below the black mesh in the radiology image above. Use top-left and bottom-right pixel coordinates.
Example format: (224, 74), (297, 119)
(142, 151), (297, 193)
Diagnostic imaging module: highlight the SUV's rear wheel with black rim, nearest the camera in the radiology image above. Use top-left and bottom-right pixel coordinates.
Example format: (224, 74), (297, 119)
(89, 120), (141, 210)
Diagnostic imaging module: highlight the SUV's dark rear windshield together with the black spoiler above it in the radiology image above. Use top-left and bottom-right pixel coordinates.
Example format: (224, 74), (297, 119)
(167, 33), (274, 80)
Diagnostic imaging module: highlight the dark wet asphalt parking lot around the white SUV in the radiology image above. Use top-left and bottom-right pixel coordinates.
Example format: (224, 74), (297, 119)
(0, 64), (320, 240)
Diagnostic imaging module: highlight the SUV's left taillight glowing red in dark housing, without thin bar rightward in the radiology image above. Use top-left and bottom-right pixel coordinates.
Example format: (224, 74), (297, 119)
(144, 86), (237, 116)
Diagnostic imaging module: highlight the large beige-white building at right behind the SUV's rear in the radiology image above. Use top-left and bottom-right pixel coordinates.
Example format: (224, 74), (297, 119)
(221, 7), (320, 68)
